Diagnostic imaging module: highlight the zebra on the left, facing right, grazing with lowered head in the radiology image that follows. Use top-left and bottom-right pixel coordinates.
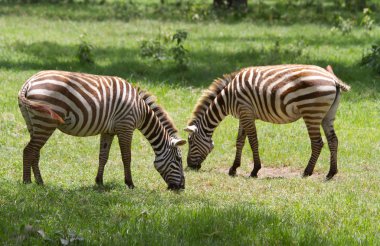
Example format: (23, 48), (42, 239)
(18, 71), (186, 189)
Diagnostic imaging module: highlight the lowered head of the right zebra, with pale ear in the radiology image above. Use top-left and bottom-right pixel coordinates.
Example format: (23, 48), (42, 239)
(184, 125), (214, 170)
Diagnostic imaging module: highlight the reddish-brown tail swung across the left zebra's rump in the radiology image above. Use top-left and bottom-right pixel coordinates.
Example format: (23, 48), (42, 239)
(18, 82), (65, 124)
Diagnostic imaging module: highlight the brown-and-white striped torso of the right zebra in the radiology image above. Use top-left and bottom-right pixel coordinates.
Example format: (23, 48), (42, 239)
(233, 65), (338, 124)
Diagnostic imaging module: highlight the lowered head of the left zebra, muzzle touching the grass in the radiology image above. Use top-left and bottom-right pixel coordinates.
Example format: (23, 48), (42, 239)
(154, 137), (186, 190)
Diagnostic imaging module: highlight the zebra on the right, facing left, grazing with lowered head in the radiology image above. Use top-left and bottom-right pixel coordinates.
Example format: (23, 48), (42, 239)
(185, 65), (350, 179)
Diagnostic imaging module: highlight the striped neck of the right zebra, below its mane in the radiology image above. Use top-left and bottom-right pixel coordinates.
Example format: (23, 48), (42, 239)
(199, 88), (230, 136)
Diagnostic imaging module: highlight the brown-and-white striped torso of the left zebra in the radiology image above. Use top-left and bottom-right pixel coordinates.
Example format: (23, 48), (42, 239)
(19, 70), (137, 136)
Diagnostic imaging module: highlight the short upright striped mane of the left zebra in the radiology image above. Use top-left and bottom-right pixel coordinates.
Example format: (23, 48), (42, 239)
(138, 88), (178, 136)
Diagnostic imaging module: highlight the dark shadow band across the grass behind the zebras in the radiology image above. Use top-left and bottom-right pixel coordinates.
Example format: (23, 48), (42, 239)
(0, 42), (380, 98)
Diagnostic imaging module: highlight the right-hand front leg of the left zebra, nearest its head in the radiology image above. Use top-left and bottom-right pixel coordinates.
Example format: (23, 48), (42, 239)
(117, 130), (135, 189)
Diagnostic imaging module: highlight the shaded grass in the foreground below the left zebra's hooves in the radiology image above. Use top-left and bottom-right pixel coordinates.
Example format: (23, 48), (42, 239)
(0, 182), (328, 245)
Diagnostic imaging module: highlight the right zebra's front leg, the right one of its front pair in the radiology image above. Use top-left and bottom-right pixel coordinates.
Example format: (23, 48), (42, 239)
(240, 114), (261, 178)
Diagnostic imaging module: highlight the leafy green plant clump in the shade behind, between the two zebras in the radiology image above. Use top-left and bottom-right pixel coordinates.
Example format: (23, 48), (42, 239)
(140, 31), (188, 67)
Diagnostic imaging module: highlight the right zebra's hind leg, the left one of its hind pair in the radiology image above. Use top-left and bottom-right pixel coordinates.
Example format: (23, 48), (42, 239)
(303, 116), (323, 177)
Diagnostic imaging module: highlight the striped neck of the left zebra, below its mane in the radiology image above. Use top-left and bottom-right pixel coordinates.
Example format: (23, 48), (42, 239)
(138, 101), (170, 156)
